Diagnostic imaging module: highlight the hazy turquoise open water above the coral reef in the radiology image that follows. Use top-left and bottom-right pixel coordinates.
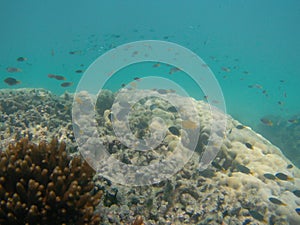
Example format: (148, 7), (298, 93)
(0, 0), (300, 165)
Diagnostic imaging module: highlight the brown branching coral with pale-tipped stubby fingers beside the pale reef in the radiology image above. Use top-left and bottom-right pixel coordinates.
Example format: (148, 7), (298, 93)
(0, 139), (102, 225)
